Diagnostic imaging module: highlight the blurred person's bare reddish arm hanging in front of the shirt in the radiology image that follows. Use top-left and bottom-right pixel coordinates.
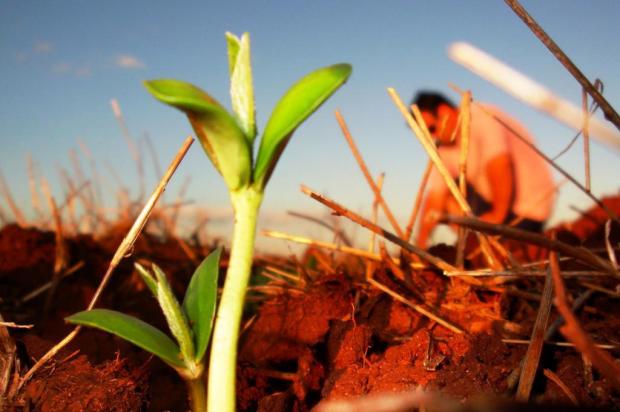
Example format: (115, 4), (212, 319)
(480, 153), (515, 223)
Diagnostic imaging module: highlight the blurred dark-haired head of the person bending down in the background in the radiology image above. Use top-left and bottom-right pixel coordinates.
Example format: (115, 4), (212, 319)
(411, 90), (459, 144)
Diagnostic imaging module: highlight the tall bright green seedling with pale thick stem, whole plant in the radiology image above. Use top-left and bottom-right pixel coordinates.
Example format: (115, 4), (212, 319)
(145, 33), (352, 412)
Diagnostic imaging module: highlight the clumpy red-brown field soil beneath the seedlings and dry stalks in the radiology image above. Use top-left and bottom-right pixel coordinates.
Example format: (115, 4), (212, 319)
(0, 198), (620, 411)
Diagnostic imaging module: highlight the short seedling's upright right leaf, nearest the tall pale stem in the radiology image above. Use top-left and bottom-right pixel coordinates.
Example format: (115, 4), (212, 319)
(183, 248), (222, 362)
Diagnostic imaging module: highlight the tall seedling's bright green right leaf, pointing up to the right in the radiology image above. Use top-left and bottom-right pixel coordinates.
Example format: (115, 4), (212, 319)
(253, 63), (352, 190)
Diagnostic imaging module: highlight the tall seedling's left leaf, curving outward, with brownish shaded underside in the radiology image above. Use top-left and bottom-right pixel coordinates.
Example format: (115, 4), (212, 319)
(144, 79), (252, 190)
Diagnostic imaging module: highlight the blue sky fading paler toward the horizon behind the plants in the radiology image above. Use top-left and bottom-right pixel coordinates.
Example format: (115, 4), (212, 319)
(0, 0), (620, 248)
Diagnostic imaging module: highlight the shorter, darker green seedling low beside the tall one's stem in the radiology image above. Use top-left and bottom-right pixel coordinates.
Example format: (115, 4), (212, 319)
(66, 248), (221, 412)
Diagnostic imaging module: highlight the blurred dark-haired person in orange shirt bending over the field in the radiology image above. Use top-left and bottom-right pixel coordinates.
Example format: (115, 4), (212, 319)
(411, 91), (555, 247)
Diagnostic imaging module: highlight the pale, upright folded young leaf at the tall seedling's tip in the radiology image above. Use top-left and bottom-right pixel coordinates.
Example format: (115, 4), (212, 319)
(226, 32), (256, 145)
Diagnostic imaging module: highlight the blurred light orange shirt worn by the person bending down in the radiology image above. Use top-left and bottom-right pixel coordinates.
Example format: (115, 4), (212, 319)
(429, 105), (555, 221)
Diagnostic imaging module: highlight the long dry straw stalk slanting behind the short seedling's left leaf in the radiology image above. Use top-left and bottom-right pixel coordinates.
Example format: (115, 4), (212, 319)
(16, 136), (194, 391)
